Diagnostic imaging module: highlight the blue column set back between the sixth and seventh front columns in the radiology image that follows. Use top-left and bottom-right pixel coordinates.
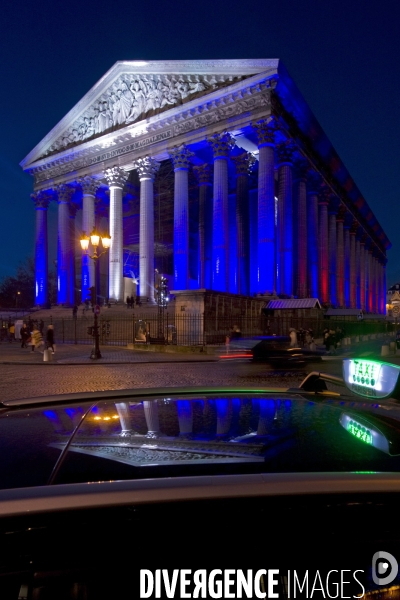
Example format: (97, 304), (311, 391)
(193, 163), (212, 289)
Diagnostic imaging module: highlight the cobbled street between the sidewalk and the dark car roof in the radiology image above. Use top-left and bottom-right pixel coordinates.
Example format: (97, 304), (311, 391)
(0, 341), (400, 400)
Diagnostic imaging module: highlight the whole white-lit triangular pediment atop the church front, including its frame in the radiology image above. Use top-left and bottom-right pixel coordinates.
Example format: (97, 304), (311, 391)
(21, 59), (278, 167)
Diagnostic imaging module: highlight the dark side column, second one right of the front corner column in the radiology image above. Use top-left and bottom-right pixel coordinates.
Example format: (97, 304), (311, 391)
(293, 160), (308, 298)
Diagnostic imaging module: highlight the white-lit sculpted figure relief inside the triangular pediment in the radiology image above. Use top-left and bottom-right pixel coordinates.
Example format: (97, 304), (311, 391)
(44, 74), (245, 156)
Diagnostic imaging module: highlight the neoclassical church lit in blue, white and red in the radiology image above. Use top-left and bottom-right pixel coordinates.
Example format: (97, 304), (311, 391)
(21, 59), (391, 314)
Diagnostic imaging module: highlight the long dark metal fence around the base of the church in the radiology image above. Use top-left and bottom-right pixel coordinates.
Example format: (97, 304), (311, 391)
(16, 312), (392, 346)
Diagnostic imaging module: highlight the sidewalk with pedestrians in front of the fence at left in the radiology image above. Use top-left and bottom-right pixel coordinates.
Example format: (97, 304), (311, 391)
(0, 341), (218, 366)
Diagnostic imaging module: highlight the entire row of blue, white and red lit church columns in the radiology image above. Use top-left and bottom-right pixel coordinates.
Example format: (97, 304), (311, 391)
(33, 125), (385, 312)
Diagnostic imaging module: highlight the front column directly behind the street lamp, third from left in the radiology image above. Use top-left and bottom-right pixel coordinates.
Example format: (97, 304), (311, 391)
(78, 175), (99, 302)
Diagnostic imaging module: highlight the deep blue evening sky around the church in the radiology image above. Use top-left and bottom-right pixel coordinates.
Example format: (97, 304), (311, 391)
(0, 0), (400, 285)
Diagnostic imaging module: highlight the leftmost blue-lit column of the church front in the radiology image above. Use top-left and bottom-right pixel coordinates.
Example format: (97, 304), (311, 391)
(31, 192), (50, 306)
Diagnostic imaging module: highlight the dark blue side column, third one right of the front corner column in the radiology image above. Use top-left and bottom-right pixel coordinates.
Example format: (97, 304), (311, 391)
(307, 173), (321, 298)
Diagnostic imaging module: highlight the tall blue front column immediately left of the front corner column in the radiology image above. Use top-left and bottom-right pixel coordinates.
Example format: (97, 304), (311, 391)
(207, 131), (235, 292)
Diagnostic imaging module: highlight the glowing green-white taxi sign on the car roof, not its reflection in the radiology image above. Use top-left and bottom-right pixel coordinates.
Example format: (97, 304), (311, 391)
(343, 358), (400, 399)
